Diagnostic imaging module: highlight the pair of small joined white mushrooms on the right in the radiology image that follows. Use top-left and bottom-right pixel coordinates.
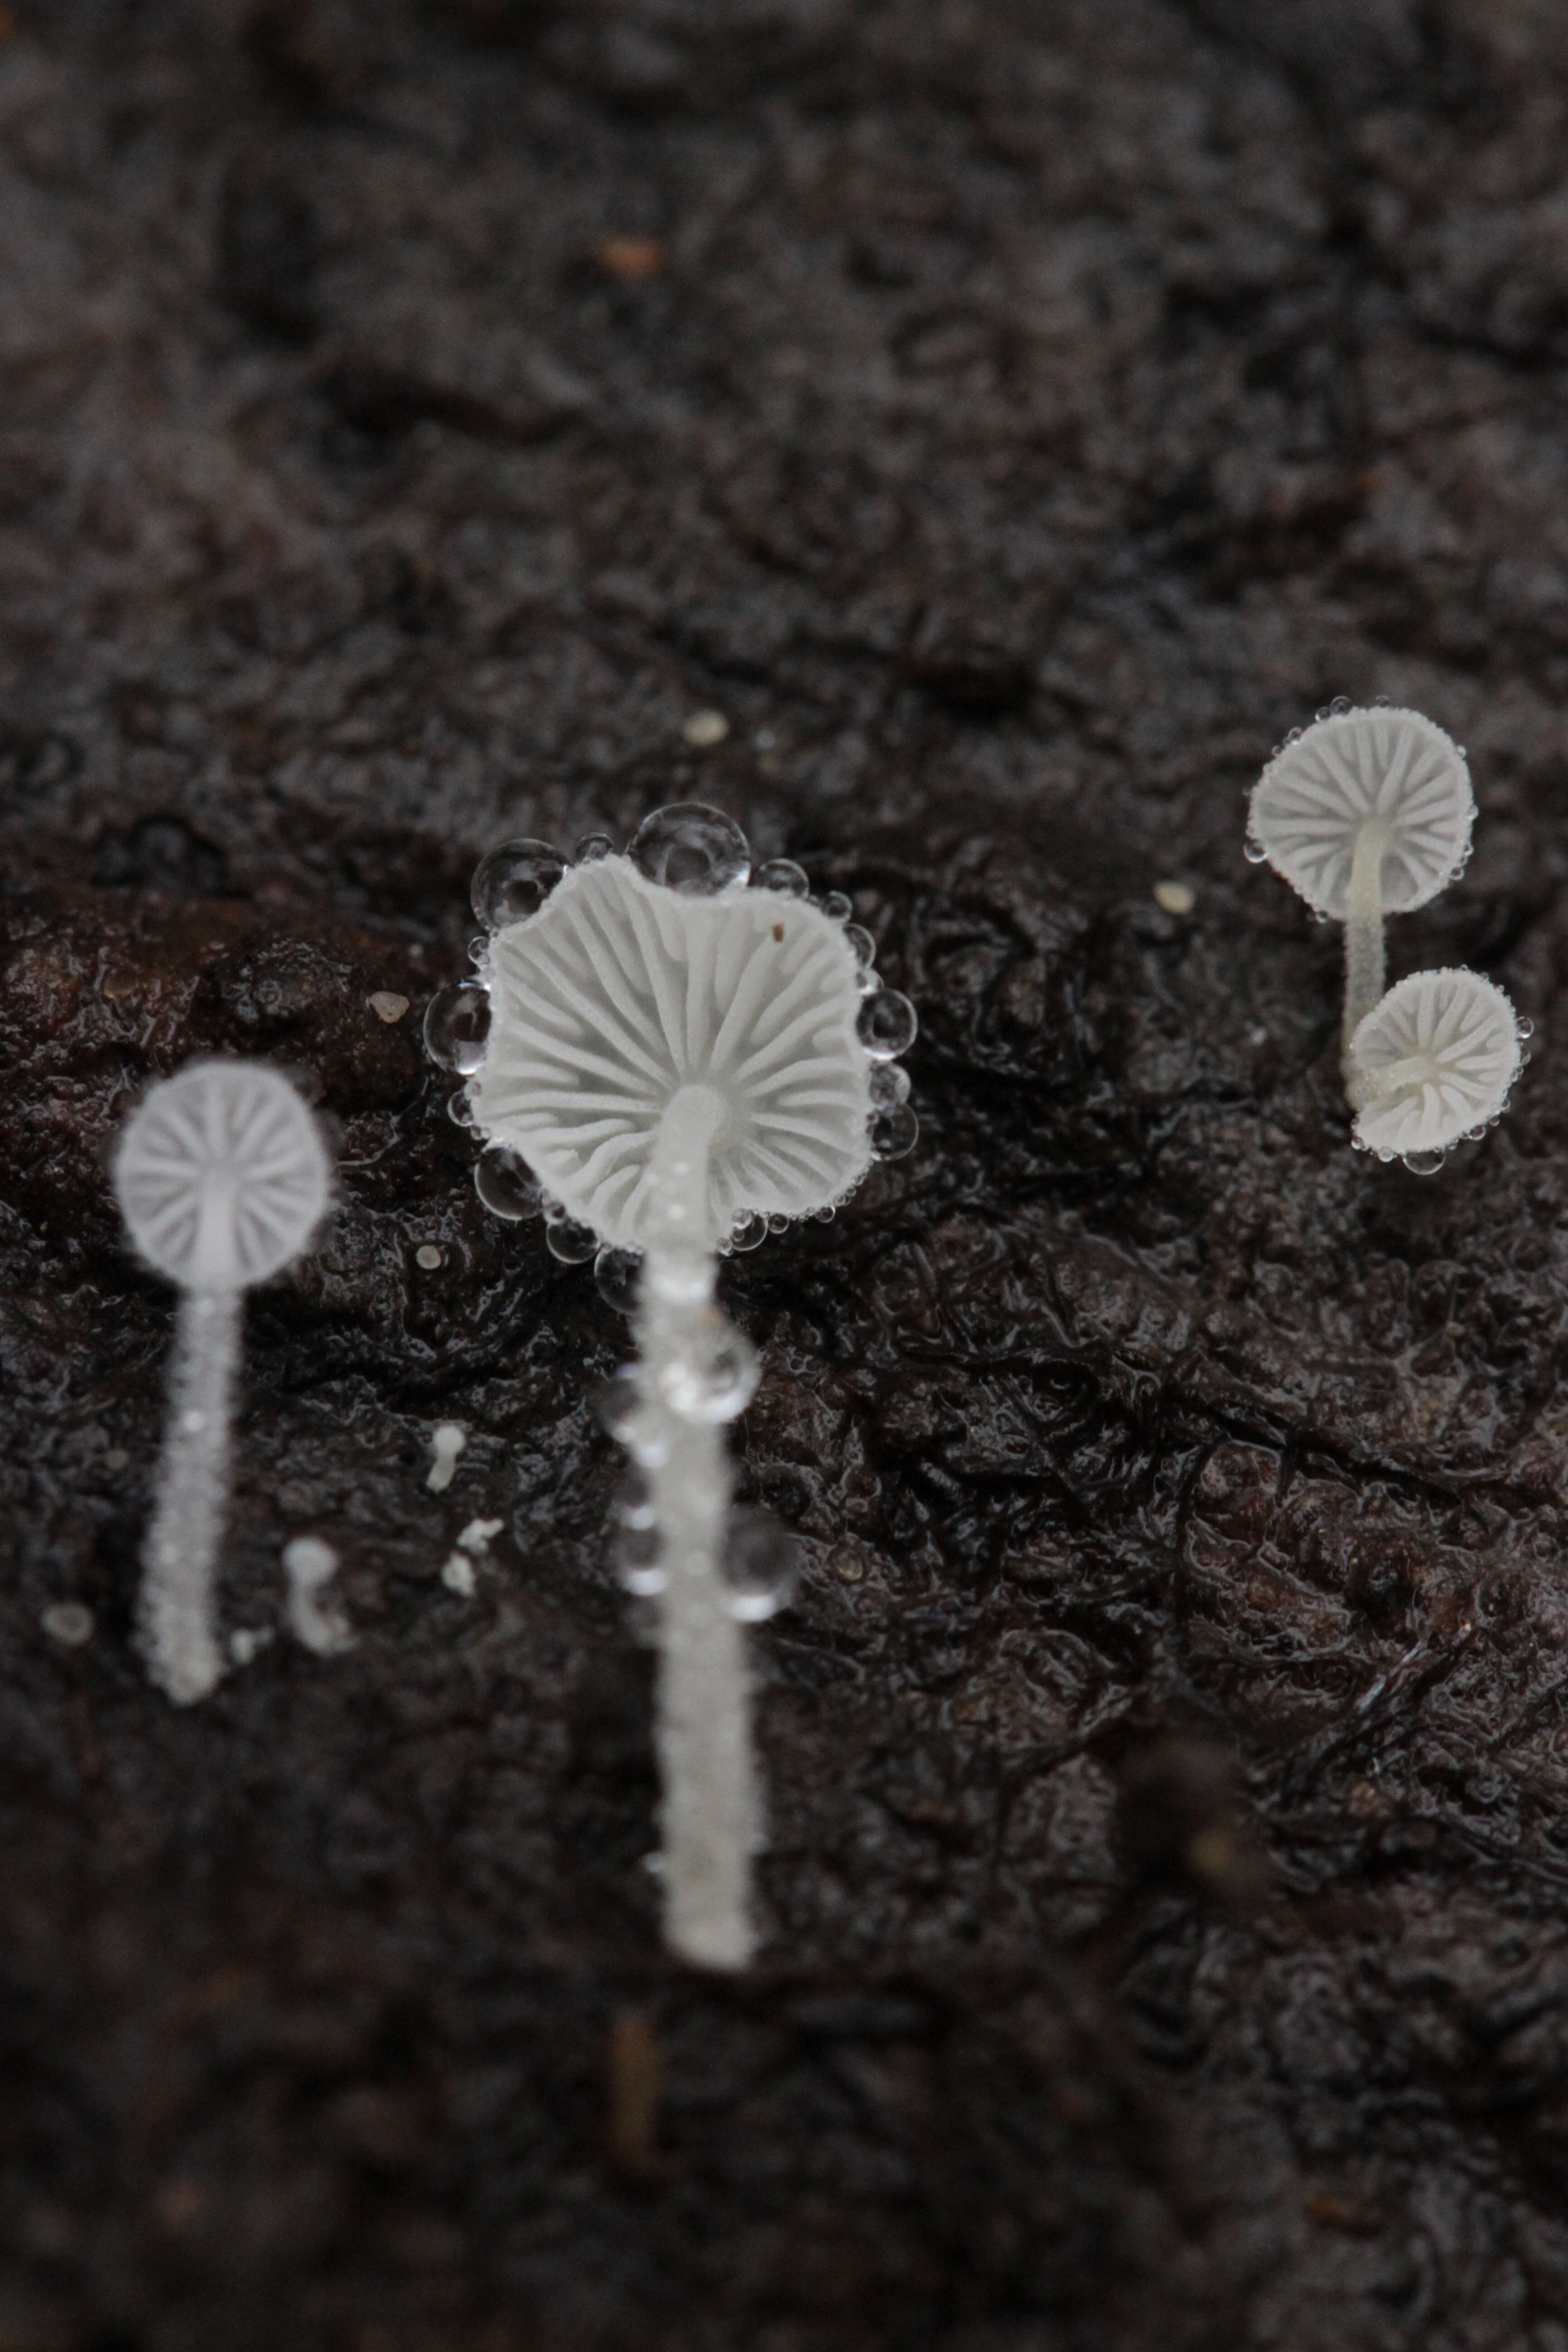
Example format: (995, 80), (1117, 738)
(1248, 706), (1530, 1176)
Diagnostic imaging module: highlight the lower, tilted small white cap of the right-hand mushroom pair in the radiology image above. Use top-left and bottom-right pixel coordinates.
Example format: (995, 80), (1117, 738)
(1349, 969), (1521, 1152)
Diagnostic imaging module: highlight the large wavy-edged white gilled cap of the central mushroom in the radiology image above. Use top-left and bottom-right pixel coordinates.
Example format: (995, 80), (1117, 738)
(468, 856), (872, 1249)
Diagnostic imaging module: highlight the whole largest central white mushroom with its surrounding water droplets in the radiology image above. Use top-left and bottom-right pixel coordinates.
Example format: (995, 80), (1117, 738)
(426, 802), (917, 1969)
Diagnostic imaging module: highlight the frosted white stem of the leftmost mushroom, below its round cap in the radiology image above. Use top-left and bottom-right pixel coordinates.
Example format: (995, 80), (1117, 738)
(139, 1289), (242, 1708)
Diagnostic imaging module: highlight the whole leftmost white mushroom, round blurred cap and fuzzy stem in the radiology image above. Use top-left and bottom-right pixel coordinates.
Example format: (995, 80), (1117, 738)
(115, 1061), (332, 1705)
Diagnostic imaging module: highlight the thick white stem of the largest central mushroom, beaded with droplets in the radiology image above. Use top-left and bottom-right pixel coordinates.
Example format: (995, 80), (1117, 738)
(637, 1087), (757, 1969)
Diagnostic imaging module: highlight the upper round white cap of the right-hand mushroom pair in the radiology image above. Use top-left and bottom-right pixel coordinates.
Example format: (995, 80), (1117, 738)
(1248, 710), (1476, 922)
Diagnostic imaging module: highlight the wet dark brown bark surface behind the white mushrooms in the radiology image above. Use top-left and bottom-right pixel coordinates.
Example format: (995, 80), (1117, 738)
(0, 0), (1568, 2352)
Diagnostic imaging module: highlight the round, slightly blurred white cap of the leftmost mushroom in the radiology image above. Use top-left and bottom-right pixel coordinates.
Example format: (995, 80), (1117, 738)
(115, 1061), (332, 1291)
